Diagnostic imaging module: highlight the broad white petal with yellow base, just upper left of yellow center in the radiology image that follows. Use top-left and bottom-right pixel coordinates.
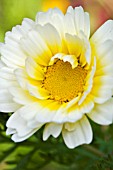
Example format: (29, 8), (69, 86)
(20, 28), (52, 66)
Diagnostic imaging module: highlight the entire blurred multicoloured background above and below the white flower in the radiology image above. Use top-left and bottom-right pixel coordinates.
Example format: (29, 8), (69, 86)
(0, 0), (113, 170)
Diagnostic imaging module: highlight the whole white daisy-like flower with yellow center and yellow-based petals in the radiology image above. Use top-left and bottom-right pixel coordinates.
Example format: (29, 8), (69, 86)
(0, 6), (113, 148)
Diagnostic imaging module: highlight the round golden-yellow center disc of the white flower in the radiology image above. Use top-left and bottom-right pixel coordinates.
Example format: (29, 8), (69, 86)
(43, 60), (87, 102)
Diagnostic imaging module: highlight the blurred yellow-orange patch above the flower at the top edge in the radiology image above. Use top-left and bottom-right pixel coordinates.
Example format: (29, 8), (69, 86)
(42, 0), (70, 13)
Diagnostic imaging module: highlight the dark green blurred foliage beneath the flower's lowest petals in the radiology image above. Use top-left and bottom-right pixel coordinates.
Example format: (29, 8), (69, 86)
(0, 113), (113, 170)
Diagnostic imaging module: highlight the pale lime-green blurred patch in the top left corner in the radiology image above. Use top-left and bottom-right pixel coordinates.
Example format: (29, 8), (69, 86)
(0, 0), (42, 41)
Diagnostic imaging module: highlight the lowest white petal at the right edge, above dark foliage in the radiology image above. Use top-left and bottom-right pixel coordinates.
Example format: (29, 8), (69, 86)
(87, 98), (113, 125)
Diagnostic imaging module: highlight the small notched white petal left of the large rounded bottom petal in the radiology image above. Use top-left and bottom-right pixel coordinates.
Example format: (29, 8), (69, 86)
(43, 123), (63, 140)
